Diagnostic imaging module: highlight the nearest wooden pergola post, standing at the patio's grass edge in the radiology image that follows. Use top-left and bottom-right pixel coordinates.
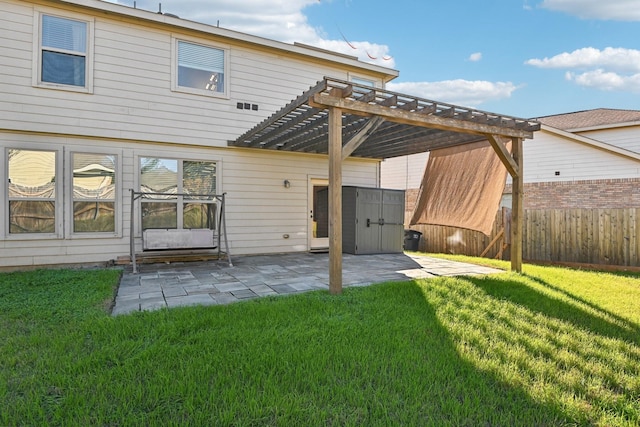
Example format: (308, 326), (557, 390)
(328, 107), (342, 295)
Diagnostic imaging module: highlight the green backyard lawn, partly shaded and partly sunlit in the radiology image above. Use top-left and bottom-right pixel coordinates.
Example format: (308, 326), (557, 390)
(0, 258), (640, 426)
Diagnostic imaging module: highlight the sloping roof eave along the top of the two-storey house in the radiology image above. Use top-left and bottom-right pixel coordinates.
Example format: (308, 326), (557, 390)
(56, 0), (399, 82)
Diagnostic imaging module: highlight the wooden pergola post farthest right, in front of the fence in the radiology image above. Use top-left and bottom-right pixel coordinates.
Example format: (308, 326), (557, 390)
(511, 137), (524, 273)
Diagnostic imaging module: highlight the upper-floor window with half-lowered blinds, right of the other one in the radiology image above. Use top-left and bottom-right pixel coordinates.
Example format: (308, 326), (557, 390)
(174, 40), (227, 96)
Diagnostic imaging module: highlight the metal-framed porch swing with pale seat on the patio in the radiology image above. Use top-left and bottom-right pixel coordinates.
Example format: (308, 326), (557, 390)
(129, 189), (233, 273)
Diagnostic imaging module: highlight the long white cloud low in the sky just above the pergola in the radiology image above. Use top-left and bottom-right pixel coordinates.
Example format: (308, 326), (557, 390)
(387, 79), (517, 107)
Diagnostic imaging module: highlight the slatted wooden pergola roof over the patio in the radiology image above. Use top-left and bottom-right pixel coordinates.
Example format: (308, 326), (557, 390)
(228, 77), (540, 159)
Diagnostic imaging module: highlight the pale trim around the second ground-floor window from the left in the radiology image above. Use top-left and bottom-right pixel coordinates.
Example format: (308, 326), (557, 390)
(64, 147), (123, 239)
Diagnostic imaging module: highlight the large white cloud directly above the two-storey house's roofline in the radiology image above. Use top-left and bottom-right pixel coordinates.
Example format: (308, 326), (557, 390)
(105, 0), (395, 68)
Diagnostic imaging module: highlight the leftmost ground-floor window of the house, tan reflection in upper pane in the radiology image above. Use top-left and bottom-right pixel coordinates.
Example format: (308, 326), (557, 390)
(6, 149), (58, 234)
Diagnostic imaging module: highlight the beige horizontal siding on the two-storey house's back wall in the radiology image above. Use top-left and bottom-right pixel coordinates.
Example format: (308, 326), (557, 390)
(0, 0), (389, 267)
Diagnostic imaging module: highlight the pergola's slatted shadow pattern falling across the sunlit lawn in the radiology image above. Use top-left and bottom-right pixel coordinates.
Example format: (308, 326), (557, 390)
(425, 276), (640, 425)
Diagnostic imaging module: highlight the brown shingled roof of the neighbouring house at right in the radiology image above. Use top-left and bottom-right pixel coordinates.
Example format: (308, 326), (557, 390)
(535, 108), (640, 130)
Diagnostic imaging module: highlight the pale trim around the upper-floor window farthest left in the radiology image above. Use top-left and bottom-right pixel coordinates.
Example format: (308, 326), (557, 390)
(31, 8), (95, 94)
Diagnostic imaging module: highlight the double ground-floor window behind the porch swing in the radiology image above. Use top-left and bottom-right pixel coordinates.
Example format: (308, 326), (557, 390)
(140, 157), (217, 230)
